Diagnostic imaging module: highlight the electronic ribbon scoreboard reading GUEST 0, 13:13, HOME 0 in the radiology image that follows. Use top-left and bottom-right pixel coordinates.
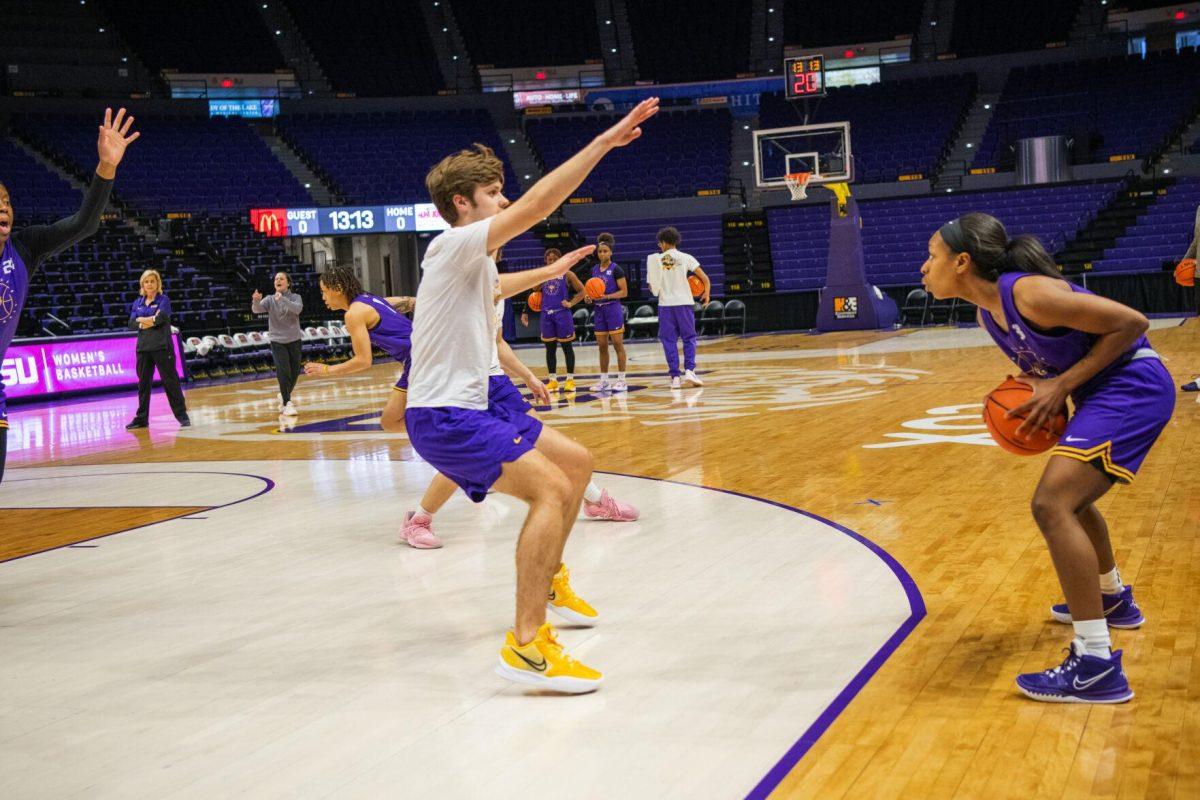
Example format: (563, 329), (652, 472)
(250, 203), (450, 237)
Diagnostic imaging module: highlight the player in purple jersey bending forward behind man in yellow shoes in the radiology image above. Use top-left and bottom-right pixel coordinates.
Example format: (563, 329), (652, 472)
(304, 266), (413, 433)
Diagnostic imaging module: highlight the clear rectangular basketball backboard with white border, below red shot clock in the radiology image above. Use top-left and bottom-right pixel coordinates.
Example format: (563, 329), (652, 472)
(754, 122), (854, 188)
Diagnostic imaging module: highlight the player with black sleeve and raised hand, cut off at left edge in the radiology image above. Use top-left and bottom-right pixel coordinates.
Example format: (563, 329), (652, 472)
(0, 108), (142, 480)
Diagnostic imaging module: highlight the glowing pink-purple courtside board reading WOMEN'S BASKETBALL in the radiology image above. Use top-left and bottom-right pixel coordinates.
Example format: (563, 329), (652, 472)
(0, 333), (184, 399)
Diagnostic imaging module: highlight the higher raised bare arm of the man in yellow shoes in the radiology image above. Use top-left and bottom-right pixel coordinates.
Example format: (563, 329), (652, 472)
(487, 97), (659, 251)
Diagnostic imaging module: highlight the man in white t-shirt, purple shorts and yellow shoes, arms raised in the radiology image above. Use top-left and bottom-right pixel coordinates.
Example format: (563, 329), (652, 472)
(404, 98), (659, 693)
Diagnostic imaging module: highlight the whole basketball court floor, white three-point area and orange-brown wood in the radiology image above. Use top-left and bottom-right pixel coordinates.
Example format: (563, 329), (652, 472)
(0, 319), (1200, 798)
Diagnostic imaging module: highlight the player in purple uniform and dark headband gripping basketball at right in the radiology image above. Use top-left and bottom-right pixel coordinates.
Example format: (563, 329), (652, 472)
(920, 213), (1175, 703)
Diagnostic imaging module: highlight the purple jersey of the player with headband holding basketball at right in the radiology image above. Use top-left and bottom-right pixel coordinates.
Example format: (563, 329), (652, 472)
(979, 272), (1150, 399)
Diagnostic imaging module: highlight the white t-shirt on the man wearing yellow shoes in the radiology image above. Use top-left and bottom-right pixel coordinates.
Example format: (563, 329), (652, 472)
(408, 218), (500, 411)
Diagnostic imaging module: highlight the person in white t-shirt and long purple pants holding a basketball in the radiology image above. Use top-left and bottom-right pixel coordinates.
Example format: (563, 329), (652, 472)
(646, 228), (713, 389)
